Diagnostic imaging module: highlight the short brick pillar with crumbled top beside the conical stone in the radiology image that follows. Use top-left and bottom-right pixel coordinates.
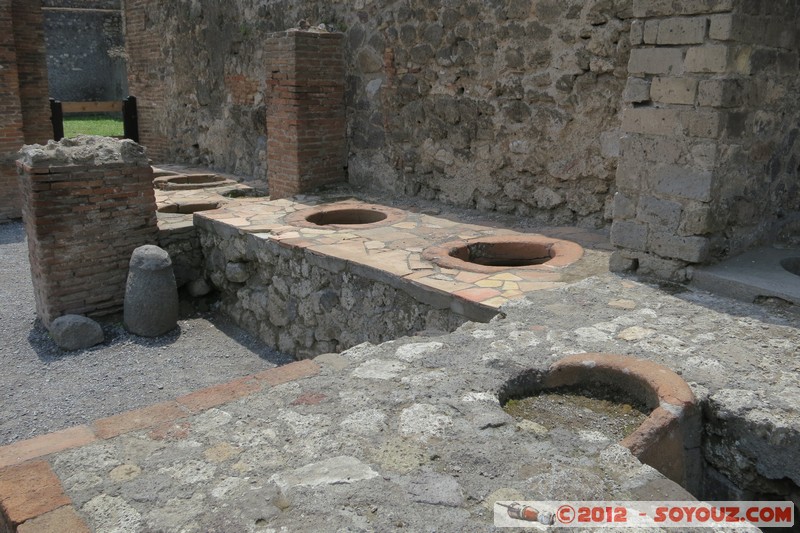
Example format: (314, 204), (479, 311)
(17, 137), (158, 327)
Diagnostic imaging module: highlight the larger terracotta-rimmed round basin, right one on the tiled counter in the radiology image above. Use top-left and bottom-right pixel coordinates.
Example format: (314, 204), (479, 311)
(422, 235), (583, 273)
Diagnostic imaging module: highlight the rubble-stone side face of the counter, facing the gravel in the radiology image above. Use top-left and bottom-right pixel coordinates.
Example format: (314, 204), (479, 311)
(195, 218), (467, 359)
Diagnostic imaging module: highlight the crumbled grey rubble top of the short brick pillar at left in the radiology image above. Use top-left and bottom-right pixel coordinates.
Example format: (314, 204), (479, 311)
(19, 135), (150, 168)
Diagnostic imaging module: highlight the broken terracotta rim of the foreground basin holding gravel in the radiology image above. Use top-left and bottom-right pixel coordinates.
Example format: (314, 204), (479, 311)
(499, 353), (702, 493)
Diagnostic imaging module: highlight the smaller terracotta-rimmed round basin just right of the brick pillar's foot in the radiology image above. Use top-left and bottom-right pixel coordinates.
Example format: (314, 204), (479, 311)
(286, 202), (406, 229)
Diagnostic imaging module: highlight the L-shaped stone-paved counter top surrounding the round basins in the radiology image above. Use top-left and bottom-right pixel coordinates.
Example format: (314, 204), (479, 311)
(0, 177), (800, 532)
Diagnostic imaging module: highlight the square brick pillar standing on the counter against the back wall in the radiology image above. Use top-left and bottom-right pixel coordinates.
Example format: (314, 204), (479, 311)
(266, 31), (346, 198)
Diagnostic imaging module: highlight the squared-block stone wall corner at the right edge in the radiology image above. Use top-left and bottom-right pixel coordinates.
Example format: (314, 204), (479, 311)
(611, 0), (800, 279)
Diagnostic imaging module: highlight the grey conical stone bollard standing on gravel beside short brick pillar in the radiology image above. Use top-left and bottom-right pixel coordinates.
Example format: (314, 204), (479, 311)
(123, 244), (178, 337)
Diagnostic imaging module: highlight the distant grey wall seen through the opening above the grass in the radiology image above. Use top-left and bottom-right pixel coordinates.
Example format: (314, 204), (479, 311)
(43, 0), (128, 101)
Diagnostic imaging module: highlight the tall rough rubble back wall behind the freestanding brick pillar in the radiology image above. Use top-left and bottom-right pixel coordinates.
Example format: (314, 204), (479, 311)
(126, 0), (631, 225)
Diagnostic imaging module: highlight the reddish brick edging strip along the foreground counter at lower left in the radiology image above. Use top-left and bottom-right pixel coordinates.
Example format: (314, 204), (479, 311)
(0, 360), (320, 533)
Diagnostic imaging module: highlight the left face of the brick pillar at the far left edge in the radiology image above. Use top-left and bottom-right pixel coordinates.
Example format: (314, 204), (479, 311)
(0, 0), (25, 222)
